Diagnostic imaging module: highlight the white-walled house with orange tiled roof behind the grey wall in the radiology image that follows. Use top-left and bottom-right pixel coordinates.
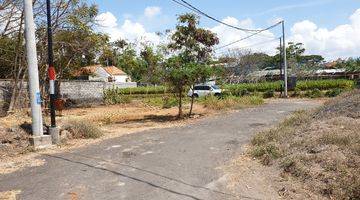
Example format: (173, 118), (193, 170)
(74, 65), (131, 83)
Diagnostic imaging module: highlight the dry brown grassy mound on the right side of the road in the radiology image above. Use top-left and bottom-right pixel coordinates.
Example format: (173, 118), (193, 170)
(249, 90), (360, 199)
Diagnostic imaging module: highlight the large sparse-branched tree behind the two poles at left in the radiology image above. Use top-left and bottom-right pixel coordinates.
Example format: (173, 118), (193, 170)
(0, 0), (108, 110)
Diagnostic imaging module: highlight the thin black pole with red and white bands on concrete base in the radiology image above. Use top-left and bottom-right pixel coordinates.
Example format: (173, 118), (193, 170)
(46, 0), (60, 144)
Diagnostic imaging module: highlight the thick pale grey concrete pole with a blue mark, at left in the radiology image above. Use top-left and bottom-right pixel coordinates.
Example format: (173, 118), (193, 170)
(24, 0), (51, 148)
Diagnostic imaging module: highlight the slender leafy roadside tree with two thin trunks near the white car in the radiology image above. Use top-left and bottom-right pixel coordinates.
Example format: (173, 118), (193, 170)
(165, 14), (219, 117)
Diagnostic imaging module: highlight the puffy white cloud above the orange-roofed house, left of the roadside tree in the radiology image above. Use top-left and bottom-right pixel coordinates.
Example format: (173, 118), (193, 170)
(96, 12), (161, 44)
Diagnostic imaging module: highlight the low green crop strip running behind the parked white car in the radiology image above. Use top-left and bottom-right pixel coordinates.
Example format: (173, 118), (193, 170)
(104, 79), (355, 104)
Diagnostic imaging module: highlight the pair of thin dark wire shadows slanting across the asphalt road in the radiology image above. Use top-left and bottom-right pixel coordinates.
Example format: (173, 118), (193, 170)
(45, 153), (258, 200)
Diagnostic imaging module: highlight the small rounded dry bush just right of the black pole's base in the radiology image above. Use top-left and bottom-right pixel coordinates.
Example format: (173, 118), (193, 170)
(65, 121), (103, 139)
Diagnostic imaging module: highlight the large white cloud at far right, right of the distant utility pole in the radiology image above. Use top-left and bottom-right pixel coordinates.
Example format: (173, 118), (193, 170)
(289, 9), (360, 59)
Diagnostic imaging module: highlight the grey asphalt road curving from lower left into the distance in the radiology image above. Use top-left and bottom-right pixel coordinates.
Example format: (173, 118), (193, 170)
(0, 100), (319, 200)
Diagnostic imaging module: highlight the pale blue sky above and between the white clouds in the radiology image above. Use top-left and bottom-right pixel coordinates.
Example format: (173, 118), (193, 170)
(88, 0), (360, 57)
